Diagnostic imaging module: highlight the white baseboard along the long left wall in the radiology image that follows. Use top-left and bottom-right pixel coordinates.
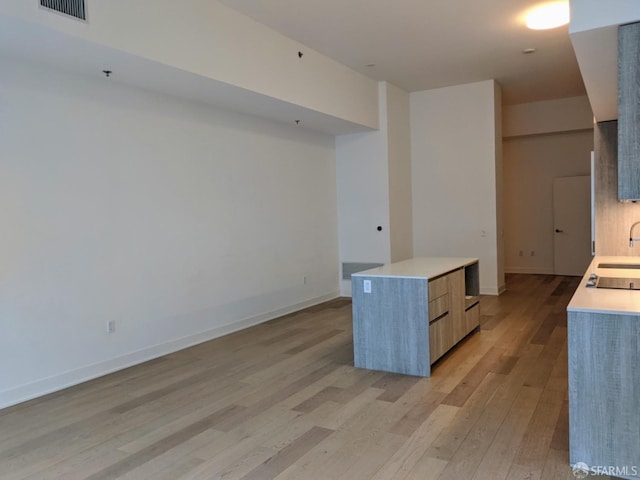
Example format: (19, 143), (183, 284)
(0, 291), (340, 409)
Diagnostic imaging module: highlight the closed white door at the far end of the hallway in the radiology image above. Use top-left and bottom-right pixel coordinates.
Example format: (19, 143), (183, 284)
(553, 175), (592, 276)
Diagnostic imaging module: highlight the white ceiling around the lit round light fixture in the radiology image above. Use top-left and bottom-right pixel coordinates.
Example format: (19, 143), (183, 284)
(220, 0), (586, 105)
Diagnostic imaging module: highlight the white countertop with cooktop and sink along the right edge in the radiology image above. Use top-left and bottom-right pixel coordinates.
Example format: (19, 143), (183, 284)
(567, 256), (640, 315)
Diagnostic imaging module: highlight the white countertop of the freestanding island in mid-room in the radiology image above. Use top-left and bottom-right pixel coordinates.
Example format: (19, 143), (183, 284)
(352, 257), (478, 280)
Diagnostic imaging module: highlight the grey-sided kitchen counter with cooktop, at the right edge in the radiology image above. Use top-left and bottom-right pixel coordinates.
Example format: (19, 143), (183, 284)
(567, 256), (640, 478)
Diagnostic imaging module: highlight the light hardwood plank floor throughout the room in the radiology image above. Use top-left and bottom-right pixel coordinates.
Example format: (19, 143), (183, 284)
(0, 275), (608, 480)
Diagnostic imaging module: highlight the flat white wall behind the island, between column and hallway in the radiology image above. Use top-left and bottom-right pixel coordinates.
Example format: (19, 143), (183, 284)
(411, 80), (504, 294)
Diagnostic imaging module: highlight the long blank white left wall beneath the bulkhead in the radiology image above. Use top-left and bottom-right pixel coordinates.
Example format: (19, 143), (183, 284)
(0, 59), (338, 408)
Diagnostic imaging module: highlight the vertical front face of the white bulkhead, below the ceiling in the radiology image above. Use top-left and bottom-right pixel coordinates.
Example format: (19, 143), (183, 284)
(0, 0), (378, 128)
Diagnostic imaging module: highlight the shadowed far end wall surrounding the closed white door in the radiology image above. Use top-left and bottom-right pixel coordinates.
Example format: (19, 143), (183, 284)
(503, 97), (593, 274)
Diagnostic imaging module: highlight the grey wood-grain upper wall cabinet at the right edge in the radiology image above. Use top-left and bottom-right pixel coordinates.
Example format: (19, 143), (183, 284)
(618, 23), (640, 200)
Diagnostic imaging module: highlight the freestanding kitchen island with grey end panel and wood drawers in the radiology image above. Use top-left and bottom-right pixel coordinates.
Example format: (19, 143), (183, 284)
(351, 257), (480, 377)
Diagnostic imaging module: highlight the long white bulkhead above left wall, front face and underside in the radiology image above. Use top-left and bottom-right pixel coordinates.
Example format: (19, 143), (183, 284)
(0, 0), (379, 135)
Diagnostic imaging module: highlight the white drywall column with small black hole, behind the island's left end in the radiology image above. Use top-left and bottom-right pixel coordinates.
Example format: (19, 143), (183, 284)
(336, 82), (412, 296)
